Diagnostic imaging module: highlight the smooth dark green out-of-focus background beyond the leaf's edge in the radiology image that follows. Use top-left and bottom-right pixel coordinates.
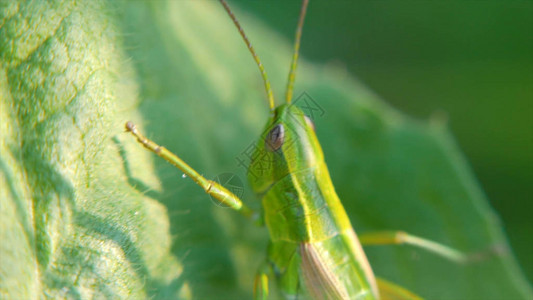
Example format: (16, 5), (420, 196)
(232, 0), (533, 281)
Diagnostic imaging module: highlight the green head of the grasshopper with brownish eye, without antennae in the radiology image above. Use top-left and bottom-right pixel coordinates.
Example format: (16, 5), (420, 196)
(248, 104), (324, 194)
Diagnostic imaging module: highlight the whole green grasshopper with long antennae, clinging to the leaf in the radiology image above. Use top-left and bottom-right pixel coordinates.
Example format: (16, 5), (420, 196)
(126, 0), (464, 299)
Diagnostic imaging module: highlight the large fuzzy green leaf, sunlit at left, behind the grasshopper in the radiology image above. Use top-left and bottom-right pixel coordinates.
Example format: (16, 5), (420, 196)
(0, 1), (532, 299)
